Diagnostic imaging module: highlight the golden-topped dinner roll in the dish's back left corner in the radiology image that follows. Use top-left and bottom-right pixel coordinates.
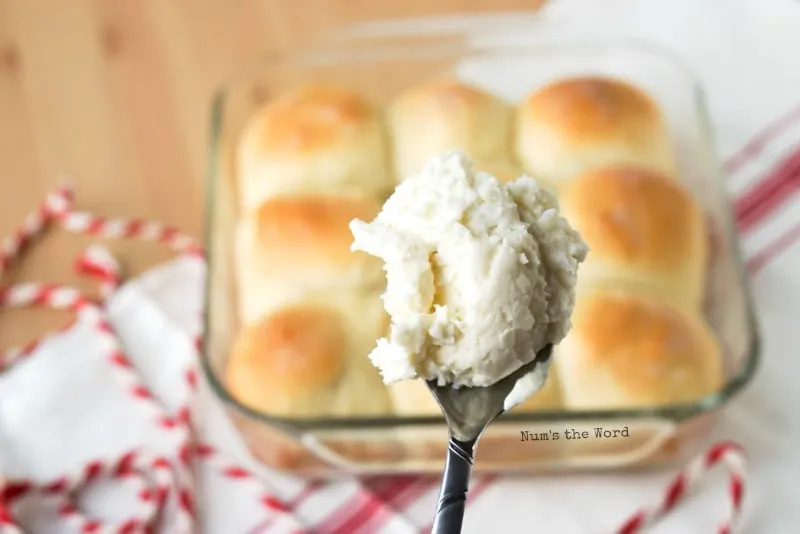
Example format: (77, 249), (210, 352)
(237, 85), (392, 210)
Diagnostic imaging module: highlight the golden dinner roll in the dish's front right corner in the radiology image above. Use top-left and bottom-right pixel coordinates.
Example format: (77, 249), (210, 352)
(554, 291), (723, 409)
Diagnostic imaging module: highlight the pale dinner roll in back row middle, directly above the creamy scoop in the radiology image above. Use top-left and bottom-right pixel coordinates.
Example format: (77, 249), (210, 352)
(388, 80), (512, 180)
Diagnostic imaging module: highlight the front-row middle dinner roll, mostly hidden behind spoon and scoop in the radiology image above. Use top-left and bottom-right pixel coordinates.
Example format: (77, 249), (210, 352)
(388, 363), (561, 417)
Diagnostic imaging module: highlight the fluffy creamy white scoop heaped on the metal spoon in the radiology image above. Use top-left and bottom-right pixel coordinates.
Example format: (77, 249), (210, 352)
(350, 152), (588, 387)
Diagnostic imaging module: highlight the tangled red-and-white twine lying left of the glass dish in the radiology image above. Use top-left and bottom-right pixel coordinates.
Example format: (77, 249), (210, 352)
(0, 186), (304, 534)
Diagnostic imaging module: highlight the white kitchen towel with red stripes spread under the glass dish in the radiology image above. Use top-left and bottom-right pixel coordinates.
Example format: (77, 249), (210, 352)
(0, 0), (800, 534)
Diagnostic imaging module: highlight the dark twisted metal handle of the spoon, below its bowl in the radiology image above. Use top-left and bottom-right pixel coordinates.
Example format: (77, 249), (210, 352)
(431, 437), (477, 534)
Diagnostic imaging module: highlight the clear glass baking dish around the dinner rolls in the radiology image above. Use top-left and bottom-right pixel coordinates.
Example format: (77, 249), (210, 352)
(202, 35), (759, 476)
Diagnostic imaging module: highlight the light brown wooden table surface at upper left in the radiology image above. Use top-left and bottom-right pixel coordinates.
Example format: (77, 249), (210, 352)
(0, 0), (541, 349)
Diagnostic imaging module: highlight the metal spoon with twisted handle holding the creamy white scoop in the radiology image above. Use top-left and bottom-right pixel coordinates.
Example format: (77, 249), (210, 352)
(427, 344), (553, 534)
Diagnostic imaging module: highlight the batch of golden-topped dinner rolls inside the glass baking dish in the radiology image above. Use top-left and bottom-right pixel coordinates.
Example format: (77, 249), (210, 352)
(226, 77), (723, 426)
